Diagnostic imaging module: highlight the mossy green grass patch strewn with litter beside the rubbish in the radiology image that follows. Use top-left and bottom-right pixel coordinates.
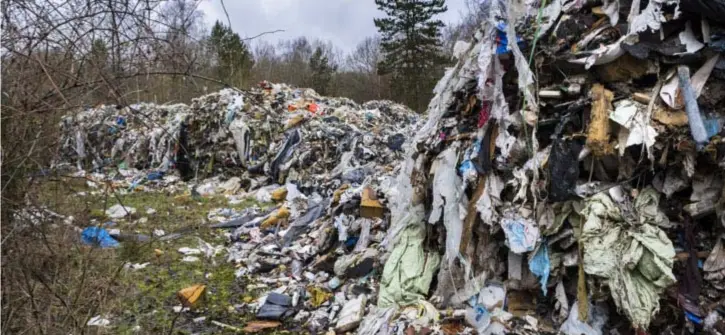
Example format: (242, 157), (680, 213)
(30, 179), (280, 334)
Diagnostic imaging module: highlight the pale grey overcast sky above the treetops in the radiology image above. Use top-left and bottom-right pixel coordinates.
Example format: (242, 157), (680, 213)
(199, 0), (465, 51)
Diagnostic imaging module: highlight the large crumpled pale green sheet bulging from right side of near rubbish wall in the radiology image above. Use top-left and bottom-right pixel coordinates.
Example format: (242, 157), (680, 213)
(580, 188), (676, 329)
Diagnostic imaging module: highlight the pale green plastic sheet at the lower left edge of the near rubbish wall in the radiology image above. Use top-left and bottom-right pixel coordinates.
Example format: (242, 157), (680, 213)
(378, 223), (441, 308)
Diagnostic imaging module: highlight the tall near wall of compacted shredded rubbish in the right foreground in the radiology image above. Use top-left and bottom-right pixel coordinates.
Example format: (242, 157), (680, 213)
(358, 0), (725, 335)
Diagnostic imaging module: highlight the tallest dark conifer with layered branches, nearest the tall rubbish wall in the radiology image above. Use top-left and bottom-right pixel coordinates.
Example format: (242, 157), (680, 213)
(374, 0), (448, 111)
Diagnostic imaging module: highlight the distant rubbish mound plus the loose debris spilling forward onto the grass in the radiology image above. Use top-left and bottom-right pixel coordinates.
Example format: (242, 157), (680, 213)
(58, 82), (419, 332)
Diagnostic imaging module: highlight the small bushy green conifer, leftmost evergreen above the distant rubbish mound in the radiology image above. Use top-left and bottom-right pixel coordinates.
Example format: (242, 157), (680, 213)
(209, 21), (254, 87)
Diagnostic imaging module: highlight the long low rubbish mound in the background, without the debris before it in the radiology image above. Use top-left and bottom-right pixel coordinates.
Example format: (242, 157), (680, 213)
(60, 82), (418, 189)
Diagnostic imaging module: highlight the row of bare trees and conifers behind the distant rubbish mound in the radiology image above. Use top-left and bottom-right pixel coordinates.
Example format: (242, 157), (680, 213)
(3, 0), (484, 112)
